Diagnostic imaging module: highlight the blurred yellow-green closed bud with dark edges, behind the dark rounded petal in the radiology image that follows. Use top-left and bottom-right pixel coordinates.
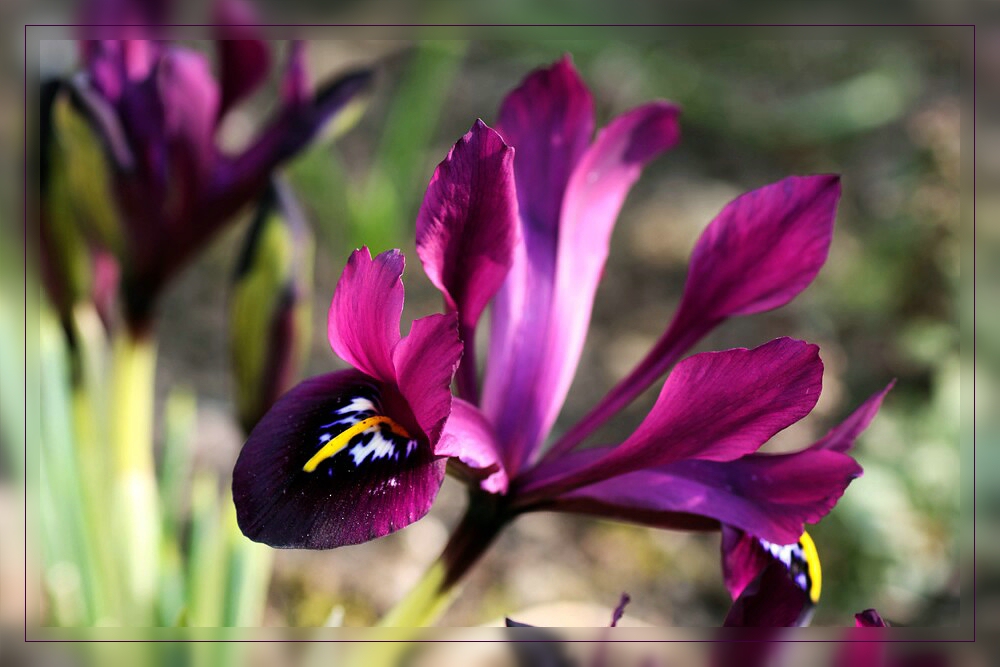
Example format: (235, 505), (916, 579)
(229, 180), (314, 433)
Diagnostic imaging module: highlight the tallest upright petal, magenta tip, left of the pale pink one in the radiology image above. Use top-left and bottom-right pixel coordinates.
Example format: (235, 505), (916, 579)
(481, 56), (594, 474)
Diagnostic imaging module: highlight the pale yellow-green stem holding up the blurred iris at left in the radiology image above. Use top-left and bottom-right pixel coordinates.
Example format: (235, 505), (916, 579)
(109, 332), (160, 625)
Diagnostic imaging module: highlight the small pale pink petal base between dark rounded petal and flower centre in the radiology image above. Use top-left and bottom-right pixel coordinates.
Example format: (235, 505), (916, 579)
(434, 398), (509, 493)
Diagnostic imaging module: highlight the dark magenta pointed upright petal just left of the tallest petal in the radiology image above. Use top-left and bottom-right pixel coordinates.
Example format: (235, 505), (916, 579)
(417, 120), (519, 331)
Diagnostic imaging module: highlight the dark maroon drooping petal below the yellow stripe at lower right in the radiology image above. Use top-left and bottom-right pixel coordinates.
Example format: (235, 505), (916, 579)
(723, 561), (813, 628)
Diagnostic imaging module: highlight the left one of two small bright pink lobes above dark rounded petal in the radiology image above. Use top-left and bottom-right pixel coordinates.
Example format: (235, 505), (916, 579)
(327, 248), (405, 383)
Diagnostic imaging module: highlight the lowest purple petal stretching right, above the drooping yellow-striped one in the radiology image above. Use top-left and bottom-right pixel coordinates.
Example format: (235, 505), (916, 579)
(553, 450), (861, 548)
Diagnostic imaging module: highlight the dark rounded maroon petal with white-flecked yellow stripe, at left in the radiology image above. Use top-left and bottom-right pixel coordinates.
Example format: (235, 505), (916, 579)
(233, 371), (445, 549)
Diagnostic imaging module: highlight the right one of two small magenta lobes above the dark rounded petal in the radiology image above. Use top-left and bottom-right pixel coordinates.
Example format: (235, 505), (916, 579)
(392, 313), (462, 444)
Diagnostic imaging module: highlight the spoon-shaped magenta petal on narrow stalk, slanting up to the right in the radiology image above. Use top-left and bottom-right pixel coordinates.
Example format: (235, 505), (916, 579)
(553, 175), (840, 454)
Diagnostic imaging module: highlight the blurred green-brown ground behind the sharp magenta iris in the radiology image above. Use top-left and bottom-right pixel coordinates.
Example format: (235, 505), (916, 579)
(0, 24), (969, 626)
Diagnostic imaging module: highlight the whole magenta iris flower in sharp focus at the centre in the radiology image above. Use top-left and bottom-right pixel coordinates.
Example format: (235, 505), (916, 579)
(233, 58), (884, 596)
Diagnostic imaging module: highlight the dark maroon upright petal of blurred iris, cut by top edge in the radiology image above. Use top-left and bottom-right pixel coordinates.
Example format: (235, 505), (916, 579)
(212, 0), (271, 117)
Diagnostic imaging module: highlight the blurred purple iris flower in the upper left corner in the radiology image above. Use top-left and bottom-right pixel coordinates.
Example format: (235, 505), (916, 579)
(67, 0), (371, 330)
